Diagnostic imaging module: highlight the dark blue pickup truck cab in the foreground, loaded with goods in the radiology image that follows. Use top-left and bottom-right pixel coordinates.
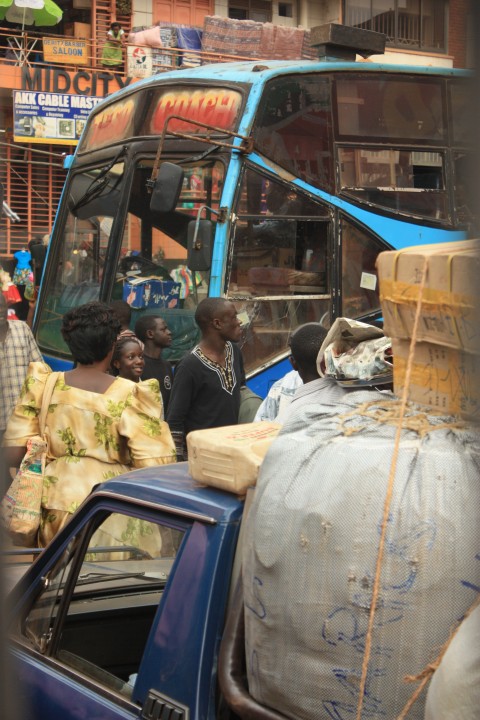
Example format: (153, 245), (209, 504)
(5, 463), (264, 720)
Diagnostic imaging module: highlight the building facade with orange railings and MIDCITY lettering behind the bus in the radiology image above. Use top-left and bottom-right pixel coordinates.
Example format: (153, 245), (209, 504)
(0, 0), (473, 264)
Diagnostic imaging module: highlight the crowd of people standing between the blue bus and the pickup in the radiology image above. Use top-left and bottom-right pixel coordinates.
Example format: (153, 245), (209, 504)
(0, 270), (394, 546)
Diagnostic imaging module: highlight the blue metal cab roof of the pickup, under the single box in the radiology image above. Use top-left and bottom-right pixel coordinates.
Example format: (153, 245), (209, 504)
(94, 462), (243, 523)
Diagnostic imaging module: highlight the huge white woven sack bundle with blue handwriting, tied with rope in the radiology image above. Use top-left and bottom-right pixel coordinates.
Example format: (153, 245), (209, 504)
(243, 391), (480, 720)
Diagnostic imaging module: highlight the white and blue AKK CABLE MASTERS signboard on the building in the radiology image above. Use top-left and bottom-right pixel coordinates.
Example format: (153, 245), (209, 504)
(13, 90), (103, 145)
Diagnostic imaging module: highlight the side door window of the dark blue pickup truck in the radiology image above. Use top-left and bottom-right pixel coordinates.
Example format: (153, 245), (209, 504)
(23, 513), (185, 697)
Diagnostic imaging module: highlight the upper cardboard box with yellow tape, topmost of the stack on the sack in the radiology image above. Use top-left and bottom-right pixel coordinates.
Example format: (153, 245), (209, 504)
(377, 240), (480, 352)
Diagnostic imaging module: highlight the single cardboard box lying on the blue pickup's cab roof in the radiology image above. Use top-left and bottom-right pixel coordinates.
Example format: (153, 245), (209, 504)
(187, 422), (281, 495)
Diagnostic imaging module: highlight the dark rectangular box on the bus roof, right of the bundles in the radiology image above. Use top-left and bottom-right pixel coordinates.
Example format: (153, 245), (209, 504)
(310, 23), (386, 62)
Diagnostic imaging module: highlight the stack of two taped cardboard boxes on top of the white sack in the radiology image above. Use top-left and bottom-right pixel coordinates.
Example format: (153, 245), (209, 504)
(377, 240), (480, 421)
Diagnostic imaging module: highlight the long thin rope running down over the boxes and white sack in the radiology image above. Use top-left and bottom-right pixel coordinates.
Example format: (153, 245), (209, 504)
(357, 258), (428, 720)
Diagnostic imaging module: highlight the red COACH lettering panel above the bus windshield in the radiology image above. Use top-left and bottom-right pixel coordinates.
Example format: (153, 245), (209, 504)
(149, 88), (242, 135)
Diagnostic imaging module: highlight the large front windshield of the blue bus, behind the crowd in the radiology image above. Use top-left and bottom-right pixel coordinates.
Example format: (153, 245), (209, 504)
(37, 158), (225, 360)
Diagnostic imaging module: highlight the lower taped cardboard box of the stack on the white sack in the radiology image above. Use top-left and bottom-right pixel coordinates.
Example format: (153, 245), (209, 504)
(392, 338), (480, 422)
